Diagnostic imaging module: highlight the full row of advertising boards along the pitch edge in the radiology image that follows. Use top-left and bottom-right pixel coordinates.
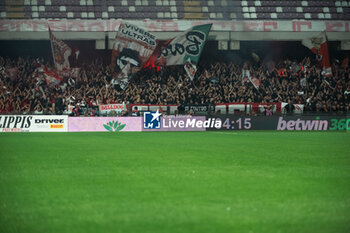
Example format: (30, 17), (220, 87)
(0, 115), (350, 132)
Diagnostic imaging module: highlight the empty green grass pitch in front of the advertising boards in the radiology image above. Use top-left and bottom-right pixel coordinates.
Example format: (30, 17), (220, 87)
(0, 131), (350, 233)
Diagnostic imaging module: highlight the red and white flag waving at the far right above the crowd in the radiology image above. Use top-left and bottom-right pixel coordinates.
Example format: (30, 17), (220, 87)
(302, 32), (332, 77)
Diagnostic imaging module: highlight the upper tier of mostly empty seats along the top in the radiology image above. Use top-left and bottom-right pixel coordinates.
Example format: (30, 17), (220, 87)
(0, 0), (350, 20)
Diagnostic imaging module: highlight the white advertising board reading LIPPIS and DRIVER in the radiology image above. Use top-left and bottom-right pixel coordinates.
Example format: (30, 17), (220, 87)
(0, 115), (68, 132)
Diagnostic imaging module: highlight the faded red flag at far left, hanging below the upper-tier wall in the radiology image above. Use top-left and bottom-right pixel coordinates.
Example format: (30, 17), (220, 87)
(49, 27), (72, 71)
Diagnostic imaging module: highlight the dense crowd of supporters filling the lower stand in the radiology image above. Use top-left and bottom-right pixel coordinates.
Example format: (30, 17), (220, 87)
(0, 55), (350, 114)
